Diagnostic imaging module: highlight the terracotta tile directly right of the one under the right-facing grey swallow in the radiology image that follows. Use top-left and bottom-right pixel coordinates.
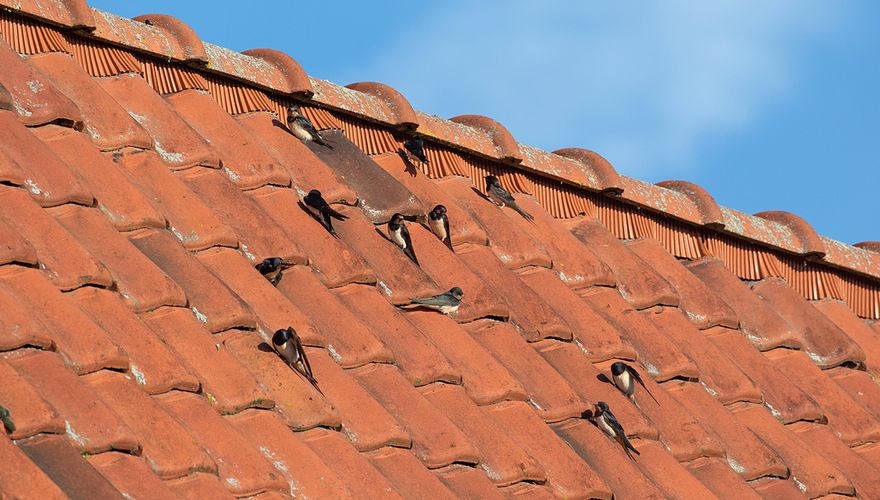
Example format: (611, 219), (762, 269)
(457, 245), (571, 342)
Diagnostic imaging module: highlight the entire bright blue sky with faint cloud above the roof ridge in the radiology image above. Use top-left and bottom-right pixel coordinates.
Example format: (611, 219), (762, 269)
(89, 0), (880, 243)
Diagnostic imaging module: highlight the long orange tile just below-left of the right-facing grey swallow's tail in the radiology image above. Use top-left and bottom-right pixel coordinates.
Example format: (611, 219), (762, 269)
(334, 285), (461, 387)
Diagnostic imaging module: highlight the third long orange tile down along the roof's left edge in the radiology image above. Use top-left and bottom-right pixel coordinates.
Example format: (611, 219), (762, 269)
(0, 186), (113, 290)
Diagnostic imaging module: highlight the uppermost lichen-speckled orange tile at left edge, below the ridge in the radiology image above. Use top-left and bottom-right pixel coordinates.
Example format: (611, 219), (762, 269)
(0, 40), (82, 130)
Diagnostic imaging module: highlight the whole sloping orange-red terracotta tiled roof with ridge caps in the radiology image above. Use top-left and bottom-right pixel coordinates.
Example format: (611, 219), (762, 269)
(0, 0), (880, 498)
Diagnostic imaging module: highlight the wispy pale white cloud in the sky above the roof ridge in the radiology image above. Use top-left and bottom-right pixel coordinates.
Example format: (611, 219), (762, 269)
(351, 0), (841, 178)
